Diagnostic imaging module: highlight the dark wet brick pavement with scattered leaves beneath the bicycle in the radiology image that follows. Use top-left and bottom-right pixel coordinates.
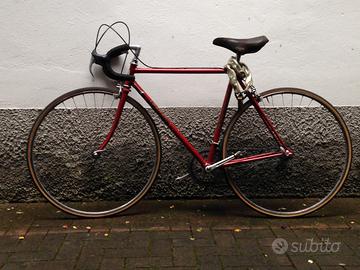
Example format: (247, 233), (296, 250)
(0, 199), (360, 270)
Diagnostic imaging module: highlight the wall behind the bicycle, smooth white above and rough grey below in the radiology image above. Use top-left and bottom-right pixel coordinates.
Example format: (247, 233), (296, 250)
(0, 0), (360, 201)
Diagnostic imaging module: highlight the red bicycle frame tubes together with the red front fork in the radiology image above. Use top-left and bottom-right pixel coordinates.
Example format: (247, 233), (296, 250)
(96, 63), (293, 168)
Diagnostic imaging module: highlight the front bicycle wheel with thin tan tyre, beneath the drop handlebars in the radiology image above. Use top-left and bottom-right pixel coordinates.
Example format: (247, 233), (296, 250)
(27, 87), (161, 218)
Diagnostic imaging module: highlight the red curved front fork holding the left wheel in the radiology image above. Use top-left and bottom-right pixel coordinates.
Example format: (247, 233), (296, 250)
(93, 82), (130, 157)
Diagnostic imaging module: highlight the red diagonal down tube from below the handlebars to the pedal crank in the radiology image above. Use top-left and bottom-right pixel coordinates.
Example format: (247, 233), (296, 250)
(133, 81), (209, 167)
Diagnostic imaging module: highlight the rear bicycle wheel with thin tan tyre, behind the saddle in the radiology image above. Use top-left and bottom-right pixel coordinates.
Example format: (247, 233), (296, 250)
(222, 88), (352, 217)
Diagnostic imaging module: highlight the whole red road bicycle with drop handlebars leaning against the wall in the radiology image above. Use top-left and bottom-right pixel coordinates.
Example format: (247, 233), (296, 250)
(27, 22), (352, 217)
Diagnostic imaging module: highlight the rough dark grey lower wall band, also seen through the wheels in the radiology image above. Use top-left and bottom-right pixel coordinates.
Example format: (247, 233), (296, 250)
(0, 107), (360, 202)
